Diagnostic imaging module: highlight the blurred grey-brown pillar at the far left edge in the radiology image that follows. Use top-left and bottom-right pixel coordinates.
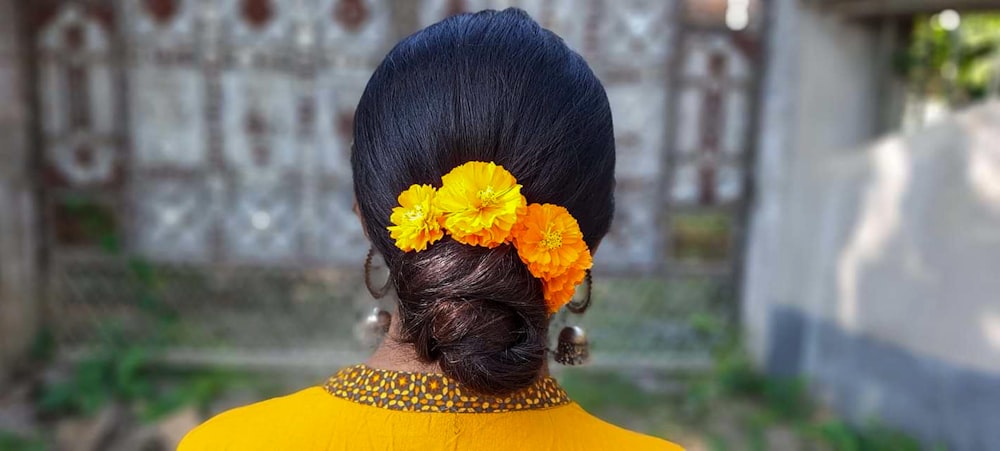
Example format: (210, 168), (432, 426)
(0, 0), (38, 381)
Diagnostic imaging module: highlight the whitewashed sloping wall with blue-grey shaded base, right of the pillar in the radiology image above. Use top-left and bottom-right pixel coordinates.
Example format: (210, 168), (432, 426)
(748, 98), (1000, 450)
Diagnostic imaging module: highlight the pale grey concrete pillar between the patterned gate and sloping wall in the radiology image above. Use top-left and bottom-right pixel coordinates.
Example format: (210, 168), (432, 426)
(741, 0), (886, 370)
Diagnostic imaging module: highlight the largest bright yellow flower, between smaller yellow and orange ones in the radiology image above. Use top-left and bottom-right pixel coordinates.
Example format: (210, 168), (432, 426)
(435, 161), (527, 248)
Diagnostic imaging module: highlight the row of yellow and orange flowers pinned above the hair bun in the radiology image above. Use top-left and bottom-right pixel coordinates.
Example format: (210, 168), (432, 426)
(389, 161), (594, 313)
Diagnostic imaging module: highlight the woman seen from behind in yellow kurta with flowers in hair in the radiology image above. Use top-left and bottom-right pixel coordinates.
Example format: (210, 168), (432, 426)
(180, 9), (680, 451)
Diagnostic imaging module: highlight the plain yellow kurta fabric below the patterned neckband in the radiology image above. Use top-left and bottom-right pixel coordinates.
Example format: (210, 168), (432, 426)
(178, 370), (682, 451)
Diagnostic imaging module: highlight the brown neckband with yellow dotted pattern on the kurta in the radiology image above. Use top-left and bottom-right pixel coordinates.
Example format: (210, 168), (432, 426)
(323, 364), (570, 413)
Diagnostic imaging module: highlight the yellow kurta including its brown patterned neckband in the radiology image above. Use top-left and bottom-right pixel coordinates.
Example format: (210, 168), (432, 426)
(178, 365), (681, 451)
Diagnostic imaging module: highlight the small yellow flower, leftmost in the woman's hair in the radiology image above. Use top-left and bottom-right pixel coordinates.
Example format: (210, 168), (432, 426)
(388, 185), (444, 252)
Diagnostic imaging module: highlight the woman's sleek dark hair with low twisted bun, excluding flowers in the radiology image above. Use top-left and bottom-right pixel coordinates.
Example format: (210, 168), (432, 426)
(351, 9), (615, 394)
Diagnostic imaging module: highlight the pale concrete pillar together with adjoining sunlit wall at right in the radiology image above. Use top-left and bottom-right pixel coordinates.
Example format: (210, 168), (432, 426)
(742, 0), (1000, 450)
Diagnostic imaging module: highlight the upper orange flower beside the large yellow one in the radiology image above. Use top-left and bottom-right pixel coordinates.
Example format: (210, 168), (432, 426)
(514, 204), (590, 279)
